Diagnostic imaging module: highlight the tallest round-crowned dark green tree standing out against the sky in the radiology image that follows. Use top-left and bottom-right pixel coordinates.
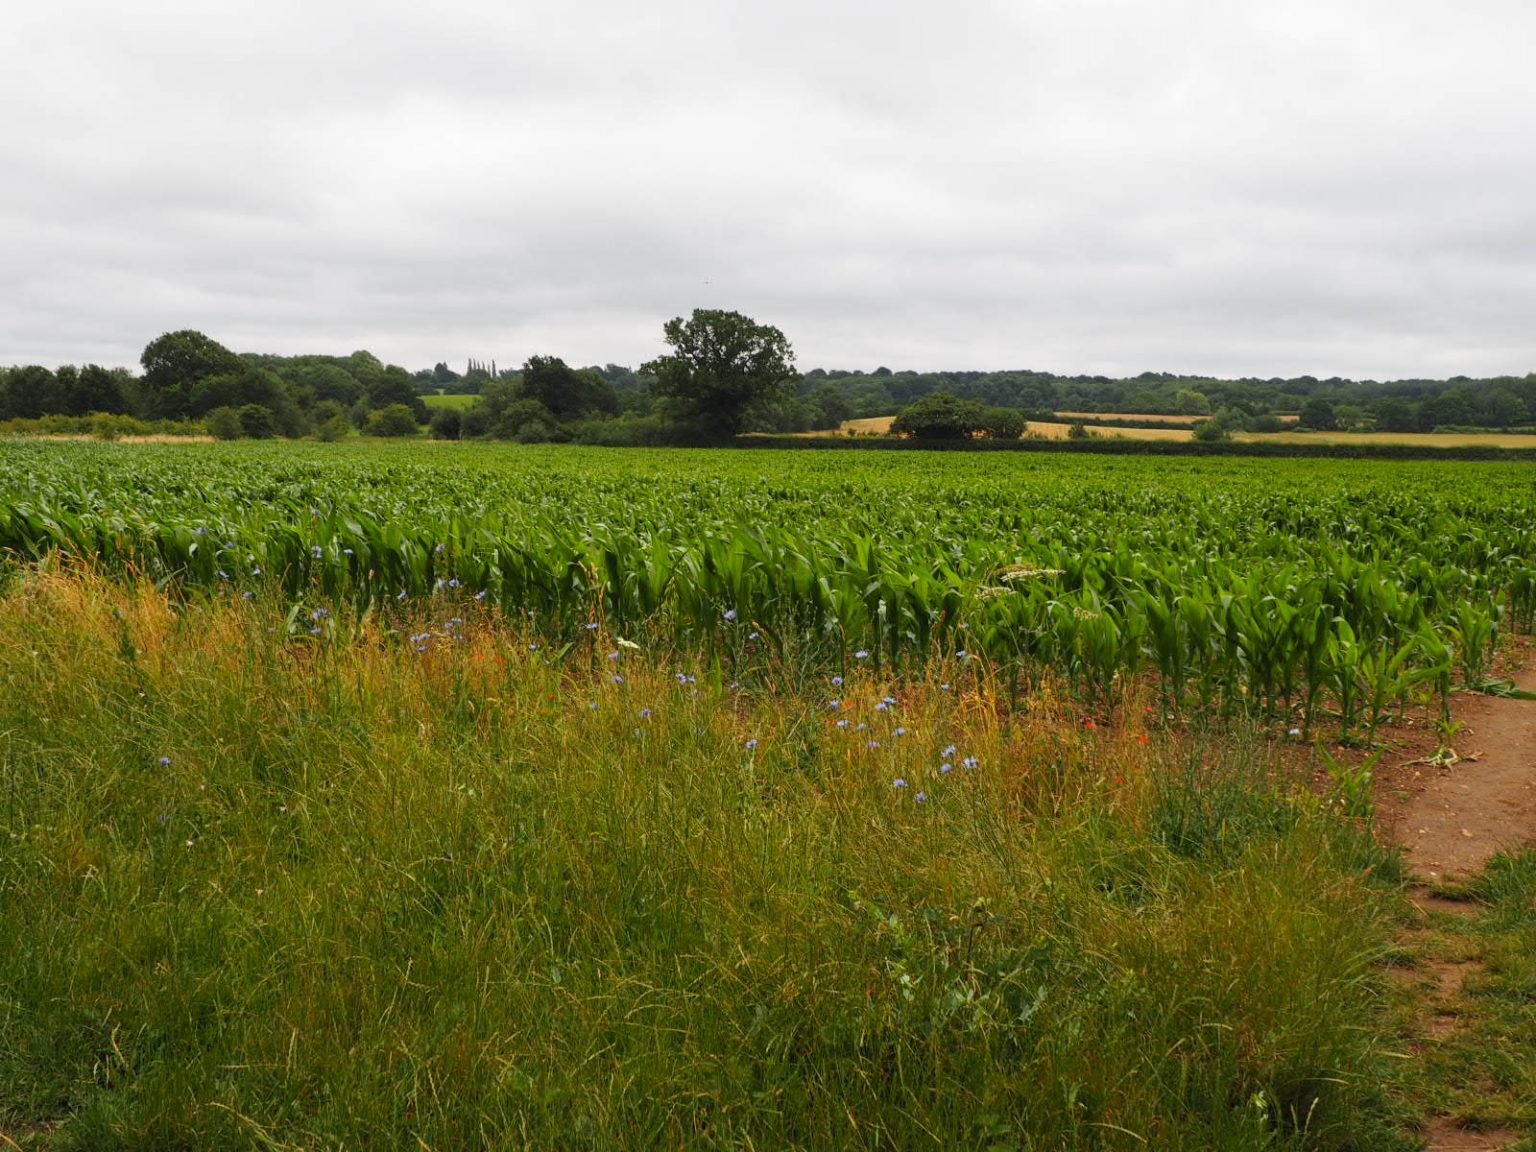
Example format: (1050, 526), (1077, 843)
(641, 309), (797, 441)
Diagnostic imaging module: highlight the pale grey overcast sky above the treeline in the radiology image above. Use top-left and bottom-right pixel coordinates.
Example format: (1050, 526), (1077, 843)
(0, 0), (1536, 378)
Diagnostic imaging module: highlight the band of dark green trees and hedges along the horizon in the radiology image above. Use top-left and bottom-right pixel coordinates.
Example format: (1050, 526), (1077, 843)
(0, 322), (1536, 444)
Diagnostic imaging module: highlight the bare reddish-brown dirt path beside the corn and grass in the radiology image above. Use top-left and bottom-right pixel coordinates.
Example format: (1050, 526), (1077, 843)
(1378, 660), (1536, 1152)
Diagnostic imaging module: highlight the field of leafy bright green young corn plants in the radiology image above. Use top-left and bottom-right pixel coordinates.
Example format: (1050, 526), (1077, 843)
(0, 444), (1536, 731)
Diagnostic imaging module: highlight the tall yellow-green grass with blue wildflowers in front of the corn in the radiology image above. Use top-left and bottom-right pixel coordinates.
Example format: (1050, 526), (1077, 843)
(0, 573), (1392, 1149)
